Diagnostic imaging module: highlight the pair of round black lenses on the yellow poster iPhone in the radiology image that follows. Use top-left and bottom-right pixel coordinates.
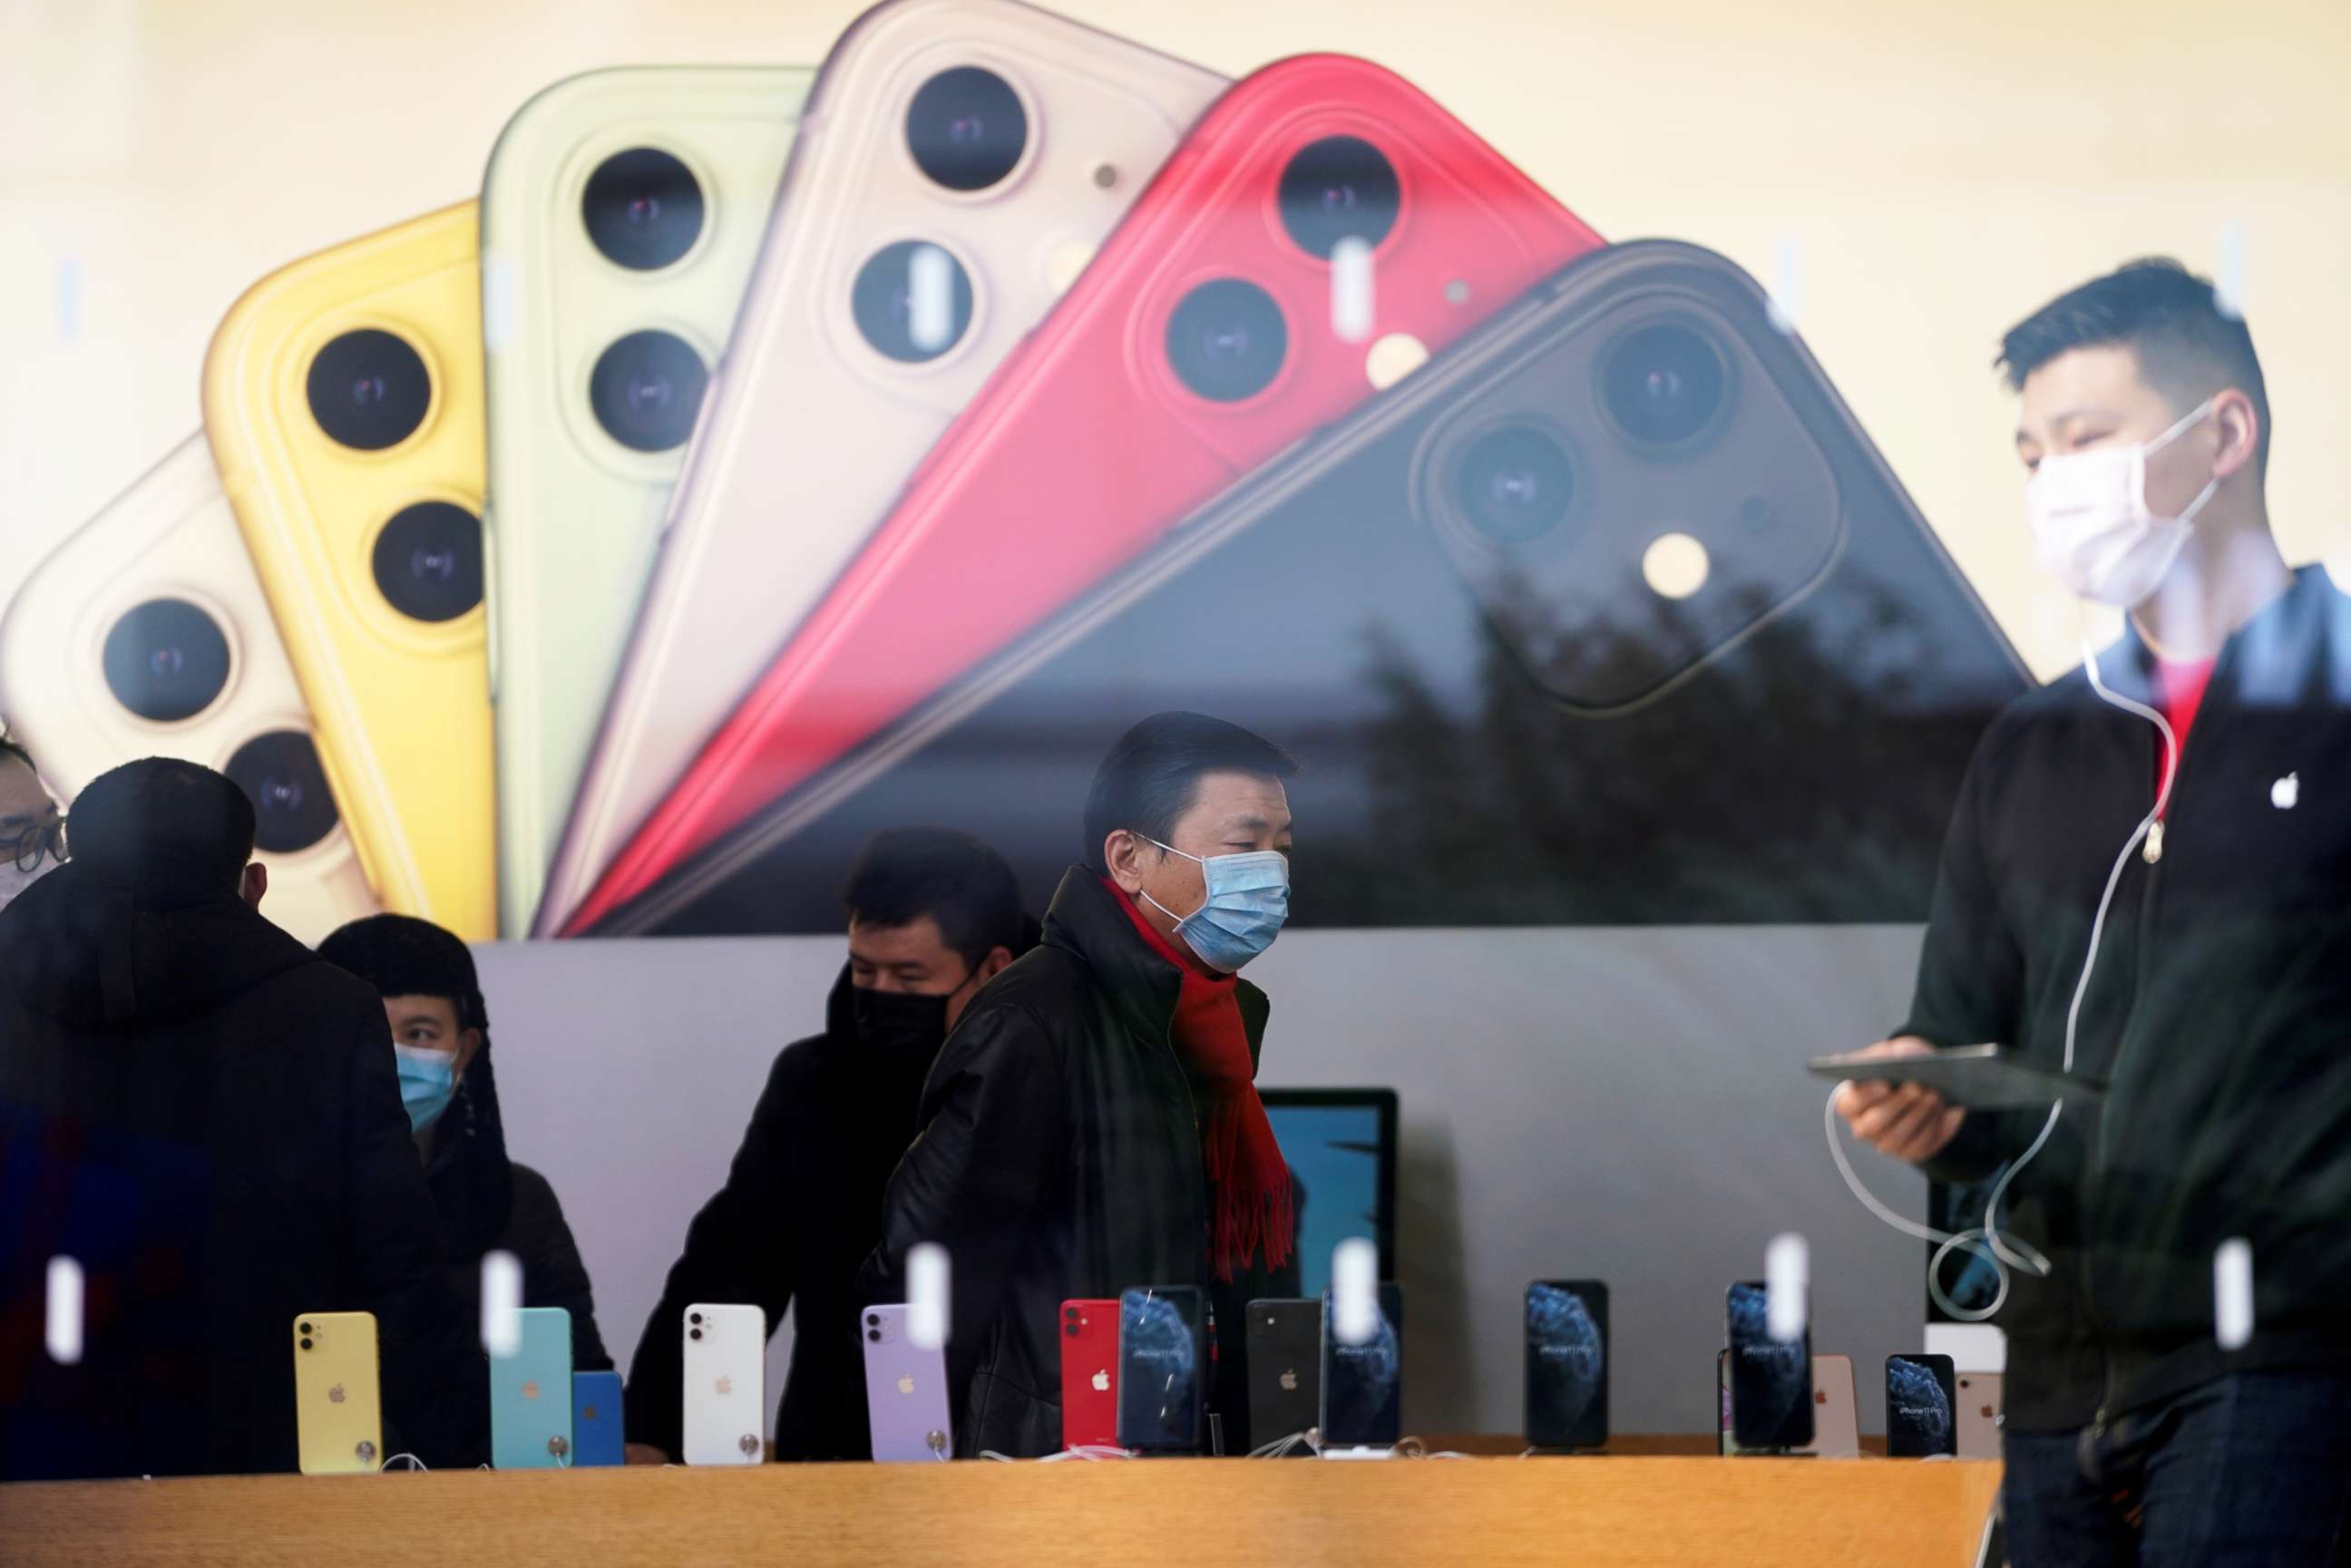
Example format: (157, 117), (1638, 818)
(305, 326), (482, 620)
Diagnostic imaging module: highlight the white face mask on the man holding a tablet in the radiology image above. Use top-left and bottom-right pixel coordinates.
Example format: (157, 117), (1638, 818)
(2024, 400), (2219, 609)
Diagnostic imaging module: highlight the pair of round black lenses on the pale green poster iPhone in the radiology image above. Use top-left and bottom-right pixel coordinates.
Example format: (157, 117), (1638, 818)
(580, 148), (710, 453)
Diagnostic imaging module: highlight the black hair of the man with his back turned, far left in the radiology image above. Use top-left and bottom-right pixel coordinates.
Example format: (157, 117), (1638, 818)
(66, 757), (254, 893)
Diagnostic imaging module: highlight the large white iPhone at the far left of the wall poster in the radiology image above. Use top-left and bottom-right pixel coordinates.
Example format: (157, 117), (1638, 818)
(0, 435), (376, 945)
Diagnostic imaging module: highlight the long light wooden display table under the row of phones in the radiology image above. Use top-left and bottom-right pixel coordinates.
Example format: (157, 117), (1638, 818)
(0, 1456), (2001, 1568)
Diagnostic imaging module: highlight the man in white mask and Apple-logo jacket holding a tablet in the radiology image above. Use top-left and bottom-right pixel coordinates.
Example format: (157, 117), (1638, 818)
(1836, 261), (2351, 1568)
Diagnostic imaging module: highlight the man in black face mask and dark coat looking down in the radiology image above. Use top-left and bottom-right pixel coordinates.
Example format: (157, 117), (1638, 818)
(625, 827), (1032, 1465)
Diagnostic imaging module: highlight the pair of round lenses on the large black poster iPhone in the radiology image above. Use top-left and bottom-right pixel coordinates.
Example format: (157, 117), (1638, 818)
(1453, 317), (1731, 548)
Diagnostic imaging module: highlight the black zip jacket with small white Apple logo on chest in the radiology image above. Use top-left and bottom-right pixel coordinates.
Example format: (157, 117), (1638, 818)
(1909, 567), (2351, 1429)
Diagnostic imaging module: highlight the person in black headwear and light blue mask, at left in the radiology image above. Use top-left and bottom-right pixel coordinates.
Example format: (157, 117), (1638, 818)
(317, 914), (611, 1373)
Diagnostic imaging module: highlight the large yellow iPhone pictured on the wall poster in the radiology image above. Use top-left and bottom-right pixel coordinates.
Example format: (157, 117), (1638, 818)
(205, 202), (499, 940)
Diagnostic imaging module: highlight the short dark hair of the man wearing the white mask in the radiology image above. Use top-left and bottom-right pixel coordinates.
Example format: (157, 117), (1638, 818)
(1994, 257), (2268, 475)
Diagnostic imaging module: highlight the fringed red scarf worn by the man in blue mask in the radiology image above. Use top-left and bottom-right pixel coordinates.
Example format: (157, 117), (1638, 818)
(1103, 877), (1298, 1279)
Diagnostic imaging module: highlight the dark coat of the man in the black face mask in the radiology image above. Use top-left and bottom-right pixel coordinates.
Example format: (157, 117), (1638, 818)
(628, 969), (919, 1460)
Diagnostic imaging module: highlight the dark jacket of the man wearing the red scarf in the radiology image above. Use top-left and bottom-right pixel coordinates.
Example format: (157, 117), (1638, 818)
(849, 868), (1295, 1457)
